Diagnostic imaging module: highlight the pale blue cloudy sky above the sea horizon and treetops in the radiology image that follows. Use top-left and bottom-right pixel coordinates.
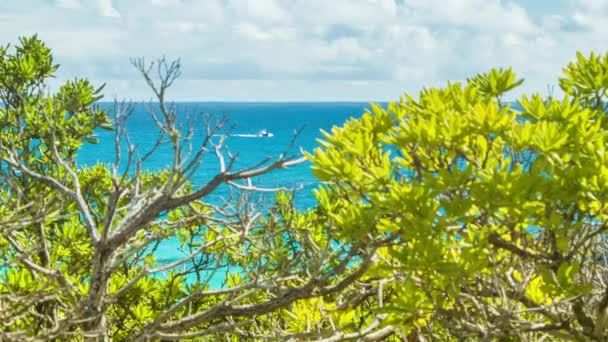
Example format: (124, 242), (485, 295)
(0, 0), (608, 101)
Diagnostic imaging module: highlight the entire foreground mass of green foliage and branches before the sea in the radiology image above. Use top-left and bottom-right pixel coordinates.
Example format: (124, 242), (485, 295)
(0, 36), (608, 341)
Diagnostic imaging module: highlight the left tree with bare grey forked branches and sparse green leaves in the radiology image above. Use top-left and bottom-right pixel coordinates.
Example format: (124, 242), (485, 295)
(0, 36), (392, 341)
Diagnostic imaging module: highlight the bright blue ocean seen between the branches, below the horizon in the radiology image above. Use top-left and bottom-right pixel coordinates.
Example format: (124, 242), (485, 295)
(78, 102), (376, 272)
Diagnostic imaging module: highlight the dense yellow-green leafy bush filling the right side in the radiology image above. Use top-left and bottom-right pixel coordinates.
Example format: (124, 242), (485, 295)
(309, 53), (608, 340)
